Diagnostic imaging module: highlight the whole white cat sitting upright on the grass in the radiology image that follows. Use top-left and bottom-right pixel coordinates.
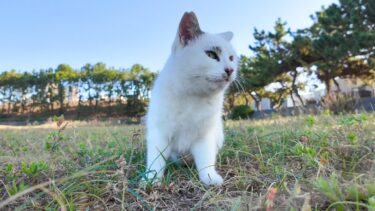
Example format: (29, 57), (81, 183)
(146, 12), (237, 185)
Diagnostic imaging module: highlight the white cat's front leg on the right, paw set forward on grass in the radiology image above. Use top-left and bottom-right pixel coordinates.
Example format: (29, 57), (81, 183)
(191, 134), (223, 185)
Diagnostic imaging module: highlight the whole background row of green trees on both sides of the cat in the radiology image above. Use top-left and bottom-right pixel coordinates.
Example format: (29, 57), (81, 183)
(0, 0), (375, 116)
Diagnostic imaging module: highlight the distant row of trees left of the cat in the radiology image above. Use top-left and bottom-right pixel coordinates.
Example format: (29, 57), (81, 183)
(0, 63), (156, 116)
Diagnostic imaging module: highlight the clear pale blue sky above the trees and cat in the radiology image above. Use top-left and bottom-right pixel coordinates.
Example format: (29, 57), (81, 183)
(0, 0), (337, 72)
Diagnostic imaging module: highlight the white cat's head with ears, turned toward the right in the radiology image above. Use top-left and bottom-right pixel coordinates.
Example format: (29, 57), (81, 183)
(172, 12), (238, 92)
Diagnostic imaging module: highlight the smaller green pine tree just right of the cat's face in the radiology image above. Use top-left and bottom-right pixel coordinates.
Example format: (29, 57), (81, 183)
(239, 19), (304, 110)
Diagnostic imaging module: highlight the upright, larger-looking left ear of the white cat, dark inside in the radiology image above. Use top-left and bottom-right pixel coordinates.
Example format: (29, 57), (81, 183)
(178, 12), (203, 46)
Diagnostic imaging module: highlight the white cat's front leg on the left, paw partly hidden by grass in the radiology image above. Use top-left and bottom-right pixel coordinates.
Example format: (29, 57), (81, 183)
(146, 129), (171, 182)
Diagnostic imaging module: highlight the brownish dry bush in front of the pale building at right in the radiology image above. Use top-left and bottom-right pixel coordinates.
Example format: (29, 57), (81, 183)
(322, 92), (358, 114)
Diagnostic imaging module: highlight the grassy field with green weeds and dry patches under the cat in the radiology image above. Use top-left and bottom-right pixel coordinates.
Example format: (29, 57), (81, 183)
(0, 113), (375, 211)
